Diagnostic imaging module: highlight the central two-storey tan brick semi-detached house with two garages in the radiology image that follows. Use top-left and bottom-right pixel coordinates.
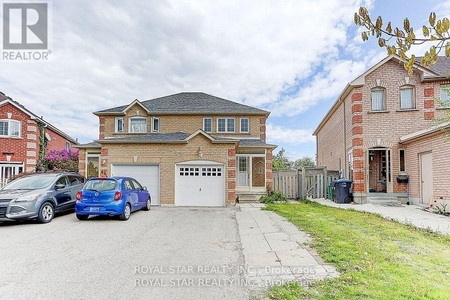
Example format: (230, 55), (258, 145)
(77, 93), (276, 206)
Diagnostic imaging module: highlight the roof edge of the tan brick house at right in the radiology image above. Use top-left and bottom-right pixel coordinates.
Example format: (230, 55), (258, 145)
(313, 54), (450, 135)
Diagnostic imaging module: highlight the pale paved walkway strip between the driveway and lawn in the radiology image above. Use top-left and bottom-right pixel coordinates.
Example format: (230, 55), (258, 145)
(236, 204), (339, 289)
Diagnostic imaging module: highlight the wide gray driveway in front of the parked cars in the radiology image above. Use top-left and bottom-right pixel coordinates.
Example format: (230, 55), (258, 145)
(0, 208), (249, 299)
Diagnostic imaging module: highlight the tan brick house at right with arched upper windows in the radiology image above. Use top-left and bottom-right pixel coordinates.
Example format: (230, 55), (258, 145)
(314, 55), (450, 204)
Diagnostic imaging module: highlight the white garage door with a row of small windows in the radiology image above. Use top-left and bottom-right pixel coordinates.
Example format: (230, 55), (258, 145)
(175, 161), (225, 206)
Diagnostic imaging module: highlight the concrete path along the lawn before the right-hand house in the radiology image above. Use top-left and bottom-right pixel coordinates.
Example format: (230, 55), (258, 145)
(311, 199), (450, 234)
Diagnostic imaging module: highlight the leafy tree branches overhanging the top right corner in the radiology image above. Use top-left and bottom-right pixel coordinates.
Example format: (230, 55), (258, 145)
(354, 6), (450, 74)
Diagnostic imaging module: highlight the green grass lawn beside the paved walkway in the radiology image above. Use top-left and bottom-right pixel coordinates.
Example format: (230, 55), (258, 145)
(267, 201), (450, 299)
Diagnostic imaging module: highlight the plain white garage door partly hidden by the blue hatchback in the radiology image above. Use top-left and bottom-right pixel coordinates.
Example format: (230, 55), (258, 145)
(111, 164), (159, 205)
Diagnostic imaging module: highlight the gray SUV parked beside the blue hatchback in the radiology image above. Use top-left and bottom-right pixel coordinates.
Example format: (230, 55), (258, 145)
(0, 173), (85, 223)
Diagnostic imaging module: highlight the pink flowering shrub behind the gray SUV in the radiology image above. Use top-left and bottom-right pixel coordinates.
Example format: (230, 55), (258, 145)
(36, 149), (78, 172)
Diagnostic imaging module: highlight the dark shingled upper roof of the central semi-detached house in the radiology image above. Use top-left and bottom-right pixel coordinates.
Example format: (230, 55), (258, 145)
(94, 92), (270, 115)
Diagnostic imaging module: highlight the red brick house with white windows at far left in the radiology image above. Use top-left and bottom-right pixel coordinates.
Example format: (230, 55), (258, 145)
(0, 92), (77, 186)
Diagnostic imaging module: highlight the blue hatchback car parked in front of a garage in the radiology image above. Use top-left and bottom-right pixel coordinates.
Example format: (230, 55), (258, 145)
(75, 177), (151, 221)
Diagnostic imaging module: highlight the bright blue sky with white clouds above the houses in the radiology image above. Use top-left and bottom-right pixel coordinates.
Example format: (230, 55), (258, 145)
(0, 0), (450, 159)
